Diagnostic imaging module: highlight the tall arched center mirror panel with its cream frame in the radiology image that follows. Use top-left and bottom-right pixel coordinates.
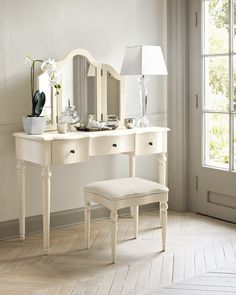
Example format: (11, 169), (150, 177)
(58, 49), (101, 124)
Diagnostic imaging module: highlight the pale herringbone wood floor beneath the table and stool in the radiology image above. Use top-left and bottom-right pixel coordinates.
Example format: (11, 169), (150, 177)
(0, 211), (236, 295)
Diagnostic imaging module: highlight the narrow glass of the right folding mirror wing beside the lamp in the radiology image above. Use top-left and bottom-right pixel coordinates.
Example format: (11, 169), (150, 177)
(107, 72), (120, 119)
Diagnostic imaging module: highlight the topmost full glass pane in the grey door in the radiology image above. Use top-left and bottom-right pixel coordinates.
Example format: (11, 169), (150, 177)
(204, 0), (229, 54)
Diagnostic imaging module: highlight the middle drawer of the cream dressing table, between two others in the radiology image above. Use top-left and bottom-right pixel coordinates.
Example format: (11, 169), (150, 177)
(90, 134), (134, 156)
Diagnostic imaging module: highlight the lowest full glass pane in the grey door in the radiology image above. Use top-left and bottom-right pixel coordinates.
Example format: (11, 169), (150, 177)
(204, 114), (229, 169)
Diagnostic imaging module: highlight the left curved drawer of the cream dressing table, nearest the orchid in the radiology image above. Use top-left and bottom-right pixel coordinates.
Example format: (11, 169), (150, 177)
(52, 138), (89, 164)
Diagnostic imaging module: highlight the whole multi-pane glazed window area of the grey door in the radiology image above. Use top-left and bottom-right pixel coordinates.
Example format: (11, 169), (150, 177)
(202, 0), (236, 171)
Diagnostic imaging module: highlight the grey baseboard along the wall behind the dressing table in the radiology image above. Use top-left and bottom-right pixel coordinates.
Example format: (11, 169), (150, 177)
(0, 203), (158, 240)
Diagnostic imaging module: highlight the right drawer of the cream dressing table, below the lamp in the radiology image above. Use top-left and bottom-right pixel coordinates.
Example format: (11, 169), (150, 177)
(135, 132), (166, 156)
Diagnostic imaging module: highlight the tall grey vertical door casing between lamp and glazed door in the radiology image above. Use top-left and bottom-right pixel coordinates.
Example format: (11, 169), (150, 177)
(167, 0), (189, 211)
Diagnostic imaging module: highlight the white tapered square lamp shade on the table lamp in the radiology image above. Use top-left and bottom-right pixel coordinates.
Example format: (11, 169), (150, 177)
(121, 46), (168, 76)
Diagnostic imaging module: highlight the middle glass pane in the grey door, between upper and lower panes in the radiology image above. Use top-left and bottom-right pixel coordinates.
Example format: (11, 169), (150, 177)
(204, 56), (229, 111)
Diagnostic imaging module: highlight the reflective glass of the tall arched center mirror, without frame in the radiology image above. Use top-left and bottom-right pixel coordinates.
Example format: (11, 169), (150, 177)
(61, 55), (97, 123)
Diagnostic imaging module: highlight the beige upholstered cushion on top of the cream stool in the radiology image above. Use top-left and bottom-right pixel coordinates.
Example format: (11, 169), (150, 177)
(84, 177), (169, 200)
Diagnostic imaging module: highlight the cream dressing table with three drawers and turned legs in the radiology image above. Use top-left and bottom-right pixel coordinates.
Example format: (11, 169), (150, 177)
(14, 127), (169, 251)
